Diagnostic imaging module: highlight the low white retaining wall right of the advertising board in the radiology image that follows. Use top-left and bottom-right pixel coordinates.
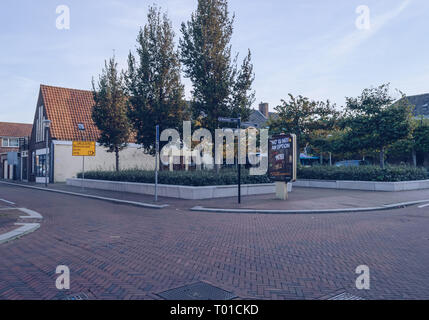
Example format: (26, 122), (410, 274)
(293, 180), (429, 192)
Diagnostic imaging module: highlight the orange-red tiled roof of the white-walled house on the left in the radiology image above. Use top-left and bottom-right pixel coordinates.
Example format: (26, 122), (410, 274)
(40, 85), (100, 141)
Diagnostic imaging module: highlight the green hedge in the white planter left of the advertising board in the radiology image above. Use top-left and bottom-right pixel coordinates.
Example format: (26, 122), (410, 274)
(78, 170), (270, 186)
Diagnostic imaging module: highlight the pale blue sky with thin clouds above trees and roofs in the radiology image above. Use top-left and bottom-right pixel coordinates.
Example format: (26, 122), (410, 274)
(0, 0), (429, 123)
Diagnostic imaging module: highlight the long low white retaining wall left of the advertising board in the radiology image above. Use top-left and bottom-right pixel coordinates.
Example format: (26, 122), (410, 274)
(67, 179), (292, 200)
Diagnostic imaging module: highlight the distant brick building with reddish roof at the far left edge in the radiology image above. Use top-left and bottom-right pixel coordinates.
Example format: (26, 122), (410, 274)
(0, 122), (33, 179)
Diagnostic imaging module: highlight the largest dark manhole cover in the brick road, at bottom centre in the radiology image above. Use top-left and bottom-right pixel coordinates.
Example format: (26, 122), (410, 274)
(158, 282), (237, 300)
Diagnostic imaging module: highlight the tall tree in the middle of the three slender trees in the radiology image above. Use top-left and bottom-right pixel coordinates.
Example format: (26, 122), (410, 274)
(126, 7), (187, 153)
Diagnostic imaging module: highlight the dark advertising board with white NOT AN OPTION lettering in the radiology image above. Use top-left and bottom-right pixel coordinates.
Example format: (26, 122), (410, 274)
(268, 134), (297, 182)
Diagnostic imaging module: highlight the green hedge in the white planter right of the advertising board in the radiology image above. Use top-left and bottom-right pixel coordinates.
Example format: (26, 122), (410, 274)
(298, 166), (429, 182)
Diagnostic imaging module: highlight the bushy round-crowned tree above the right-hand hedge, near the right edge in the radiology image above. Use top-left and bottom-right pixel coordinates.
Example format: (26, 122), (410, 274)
(343, 84), (412, 168)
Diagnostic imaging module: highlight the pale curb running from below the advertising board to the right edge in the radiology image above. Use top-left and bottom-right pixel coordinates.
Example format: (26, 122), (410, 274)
(190, 199), (429, 214)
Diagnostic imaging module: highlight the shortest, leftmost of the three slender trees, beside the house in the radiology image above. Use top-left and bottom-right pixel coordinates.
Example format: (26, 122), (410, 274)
(92, 57), (131, 171)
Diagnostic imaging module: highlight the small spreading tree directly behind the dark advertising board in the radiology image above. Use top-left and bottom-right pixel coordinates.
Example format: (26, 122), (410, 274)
(268, 94), (340, 160)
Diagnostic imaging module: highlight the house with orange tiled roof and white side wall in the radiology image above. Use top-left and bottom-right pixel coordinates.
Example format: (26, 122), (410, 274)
(29, 85), (155, 183)
